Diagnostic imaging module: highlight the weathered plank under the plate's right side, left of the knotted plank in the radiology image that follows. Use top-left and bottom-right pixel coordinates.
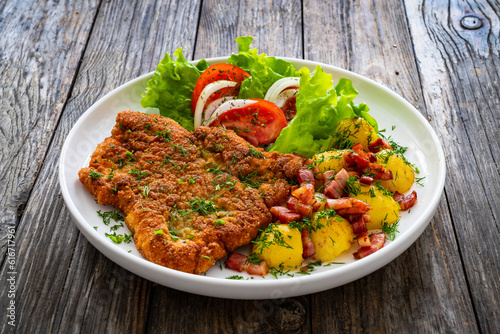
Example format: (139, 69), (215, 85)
(304, 0), (477, 333)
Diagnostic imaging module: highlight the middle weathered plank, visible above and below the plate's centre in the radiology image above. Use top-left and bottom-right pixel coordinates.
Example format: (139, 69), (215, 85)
(143, 1), (310, 333)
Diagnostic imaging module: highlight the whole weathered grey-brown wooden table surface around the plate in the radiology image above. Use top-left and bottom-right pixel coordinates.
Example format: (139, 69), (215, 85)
(0, 0), (500, 333)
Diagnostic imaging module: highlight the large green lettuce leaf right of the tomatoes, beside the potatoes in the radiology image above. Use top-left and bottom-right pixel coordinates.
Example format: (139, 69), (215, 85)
(270, 65), (376, 157)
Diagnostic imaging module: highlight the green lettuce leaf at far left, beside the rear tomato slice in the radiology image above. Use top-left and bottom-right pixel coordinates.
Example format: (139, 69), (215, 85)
(141, 48), (208, 131)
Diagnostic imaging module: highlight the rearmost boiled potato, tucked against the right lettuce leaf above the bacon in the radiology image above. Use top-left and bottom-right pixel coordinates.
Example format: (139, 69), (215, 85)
(335, 117), (378, 151)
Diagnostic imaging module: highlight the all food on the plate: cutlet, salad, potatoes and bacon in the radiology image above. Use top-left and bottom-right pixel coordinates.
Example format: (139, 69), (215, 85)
(84, 37), (418, 278)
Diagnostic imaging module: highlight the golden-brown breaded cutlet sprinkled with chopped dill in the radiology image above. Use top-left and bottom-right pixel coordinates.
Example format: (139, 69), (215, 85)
(79, 111), (302, 274)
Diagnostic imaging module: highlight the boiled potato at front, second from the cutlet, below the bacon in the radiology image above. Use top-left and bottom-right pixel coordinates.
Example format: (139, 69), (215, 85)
(311, 216), (354, 262)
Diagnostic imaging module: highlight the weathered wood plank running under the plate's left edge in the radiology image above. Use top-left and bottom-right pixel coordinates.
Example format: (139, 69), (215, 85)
(1, 1), (199, 333)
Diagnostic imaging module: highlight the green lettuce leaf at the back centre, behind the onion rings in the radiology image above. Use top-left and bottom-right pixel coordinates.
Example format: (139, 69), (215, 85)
(229, 36), (302, 99)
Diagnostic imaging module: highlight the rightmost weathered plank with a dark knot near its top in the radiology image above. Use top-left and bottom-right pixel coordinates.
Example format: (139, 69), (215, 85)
(406, 1), (500, 333)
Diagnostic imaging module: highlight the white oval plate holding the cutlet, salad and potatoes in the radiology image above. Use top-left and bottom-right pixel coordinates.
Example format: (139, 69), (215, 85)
(59, 58), (445, 299)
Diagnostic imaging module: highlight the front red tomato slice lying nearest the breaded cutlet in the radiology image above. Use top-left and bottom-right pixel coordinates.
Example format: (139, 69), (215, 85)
(210, 99), (287, 146)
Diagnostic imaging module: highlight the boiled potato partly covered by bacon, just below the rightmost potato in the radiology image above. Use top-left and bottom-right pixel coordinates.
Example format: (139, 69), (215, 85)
(350, 184), (399, 230)
